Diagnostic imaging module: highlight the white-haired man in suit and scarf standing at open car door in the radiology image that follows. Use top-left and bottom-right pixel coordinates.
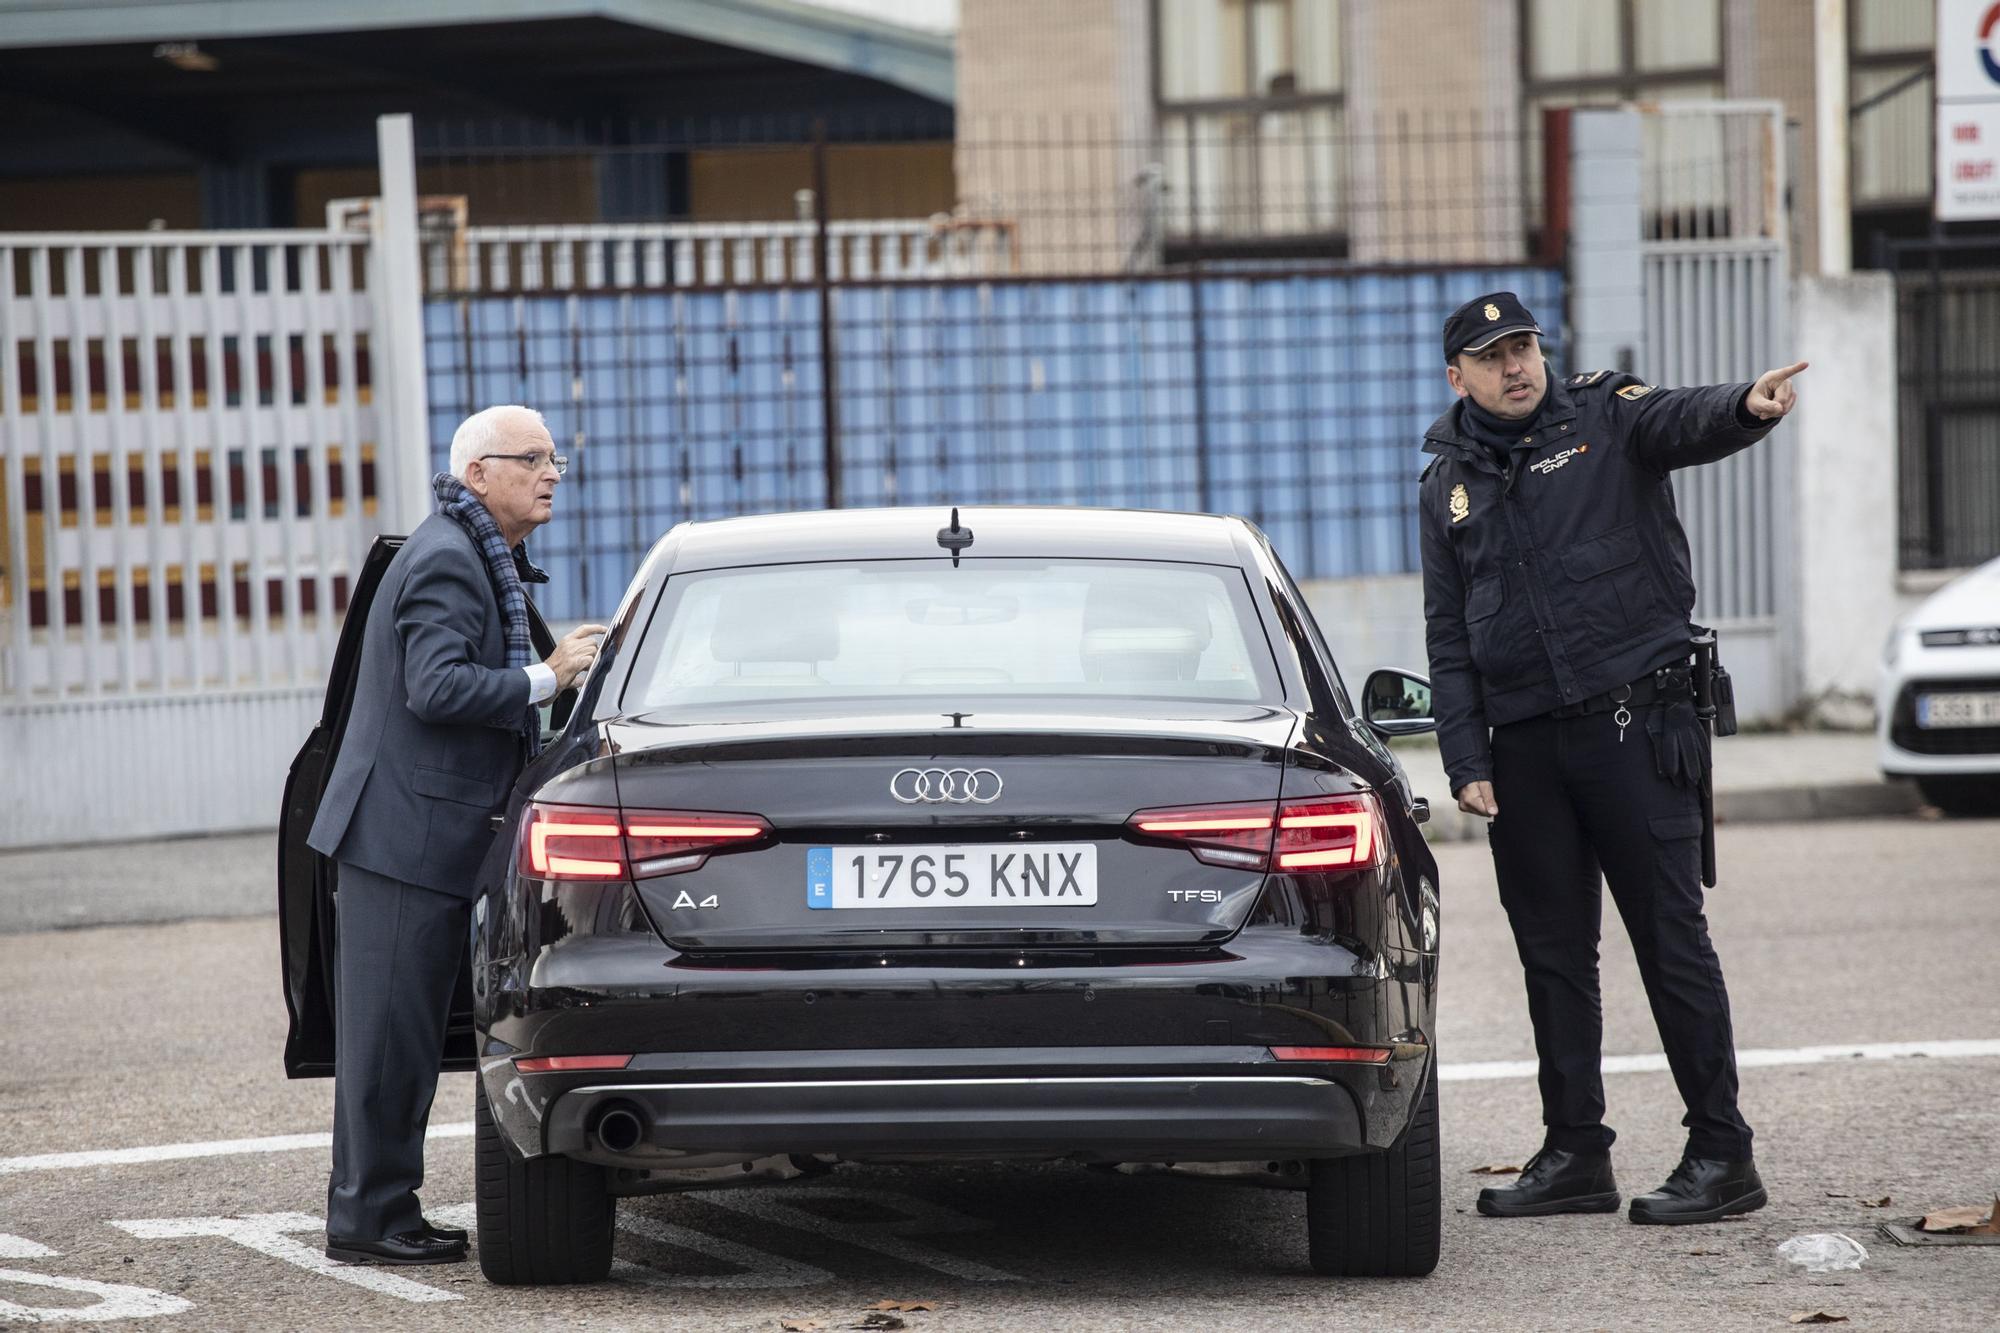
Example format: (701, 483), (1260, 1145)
(308, 406), (604, 1263)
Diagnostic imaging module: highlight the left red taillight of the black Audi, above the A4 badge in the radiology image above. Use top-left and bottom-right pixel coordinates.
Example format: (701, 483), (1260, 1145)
(516, 801), (770, 881)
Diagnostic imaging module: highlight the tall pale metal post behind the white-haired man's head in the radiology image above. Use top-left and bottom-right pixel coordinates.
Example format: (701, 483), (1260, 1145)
(368, 116), (430, 532)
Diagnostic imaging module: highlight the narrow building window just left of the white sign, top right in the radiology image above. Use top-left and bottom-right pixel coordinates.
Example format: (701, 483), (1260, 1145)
(1848, 0), (1936, 208)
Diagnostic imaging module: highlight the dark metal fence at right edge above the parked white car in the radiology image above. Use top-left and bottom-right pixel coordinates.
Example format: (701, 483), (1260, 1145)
(1878, 236), (2000, 570)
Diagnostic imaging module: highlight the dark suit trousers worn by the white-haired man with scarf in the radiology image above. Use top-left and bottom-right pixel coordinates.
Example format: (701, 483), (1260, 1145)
(326, 865), (472, 1241)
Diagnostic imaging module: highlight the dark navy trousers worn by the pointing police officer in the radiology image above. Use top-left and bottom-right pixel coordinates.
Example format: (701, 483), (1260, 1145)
(1488, 711), (1750, 1161)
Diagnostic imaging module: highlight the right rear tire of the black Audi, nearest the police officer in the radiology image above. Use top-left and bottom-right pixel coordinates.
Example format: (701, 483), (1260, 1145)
(1306, 1055), (1444, 1277)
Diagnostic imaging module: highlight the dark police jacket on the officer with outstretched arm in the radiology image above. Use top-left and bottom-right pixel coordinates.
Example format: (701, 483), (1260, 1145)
(1418, 370), (1770, 793)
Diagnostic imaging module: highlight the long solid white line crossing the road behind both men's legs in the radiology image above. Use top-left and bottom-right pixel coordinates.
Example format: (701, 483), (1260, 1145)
(0, 1039), (2000, 1175)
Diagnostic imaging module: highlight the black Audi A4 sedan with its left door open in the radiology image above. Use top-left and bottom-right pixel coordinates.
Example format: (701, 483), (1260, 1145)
(280, 508), (1440, 1283)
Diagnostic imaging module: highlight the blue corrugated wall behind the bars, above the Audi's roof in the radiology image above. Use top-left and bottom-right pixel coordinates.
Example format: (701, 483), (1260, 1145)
(426, 268), (1562, 618)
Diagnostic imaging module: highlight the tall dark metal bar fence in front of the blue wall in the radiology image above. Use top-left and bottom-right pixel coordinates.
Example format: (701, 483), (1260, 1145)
(418, 114), (1562, 616)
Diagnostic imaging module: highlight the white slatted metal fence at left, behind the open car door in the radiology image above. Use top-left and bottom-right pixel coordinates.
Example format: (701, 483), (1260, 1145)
(0, 232), (378, 847)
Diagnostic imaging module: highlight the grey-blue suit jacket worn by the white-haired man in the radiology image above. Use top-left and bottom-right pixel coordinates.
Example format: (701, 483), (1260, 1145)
(306, 514), (528, 897)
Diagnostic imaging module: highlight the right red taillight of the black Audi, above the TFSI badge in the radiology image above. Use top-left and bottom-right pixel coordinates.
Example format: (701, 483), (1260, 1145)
(1126, 793), (1384, 871)
